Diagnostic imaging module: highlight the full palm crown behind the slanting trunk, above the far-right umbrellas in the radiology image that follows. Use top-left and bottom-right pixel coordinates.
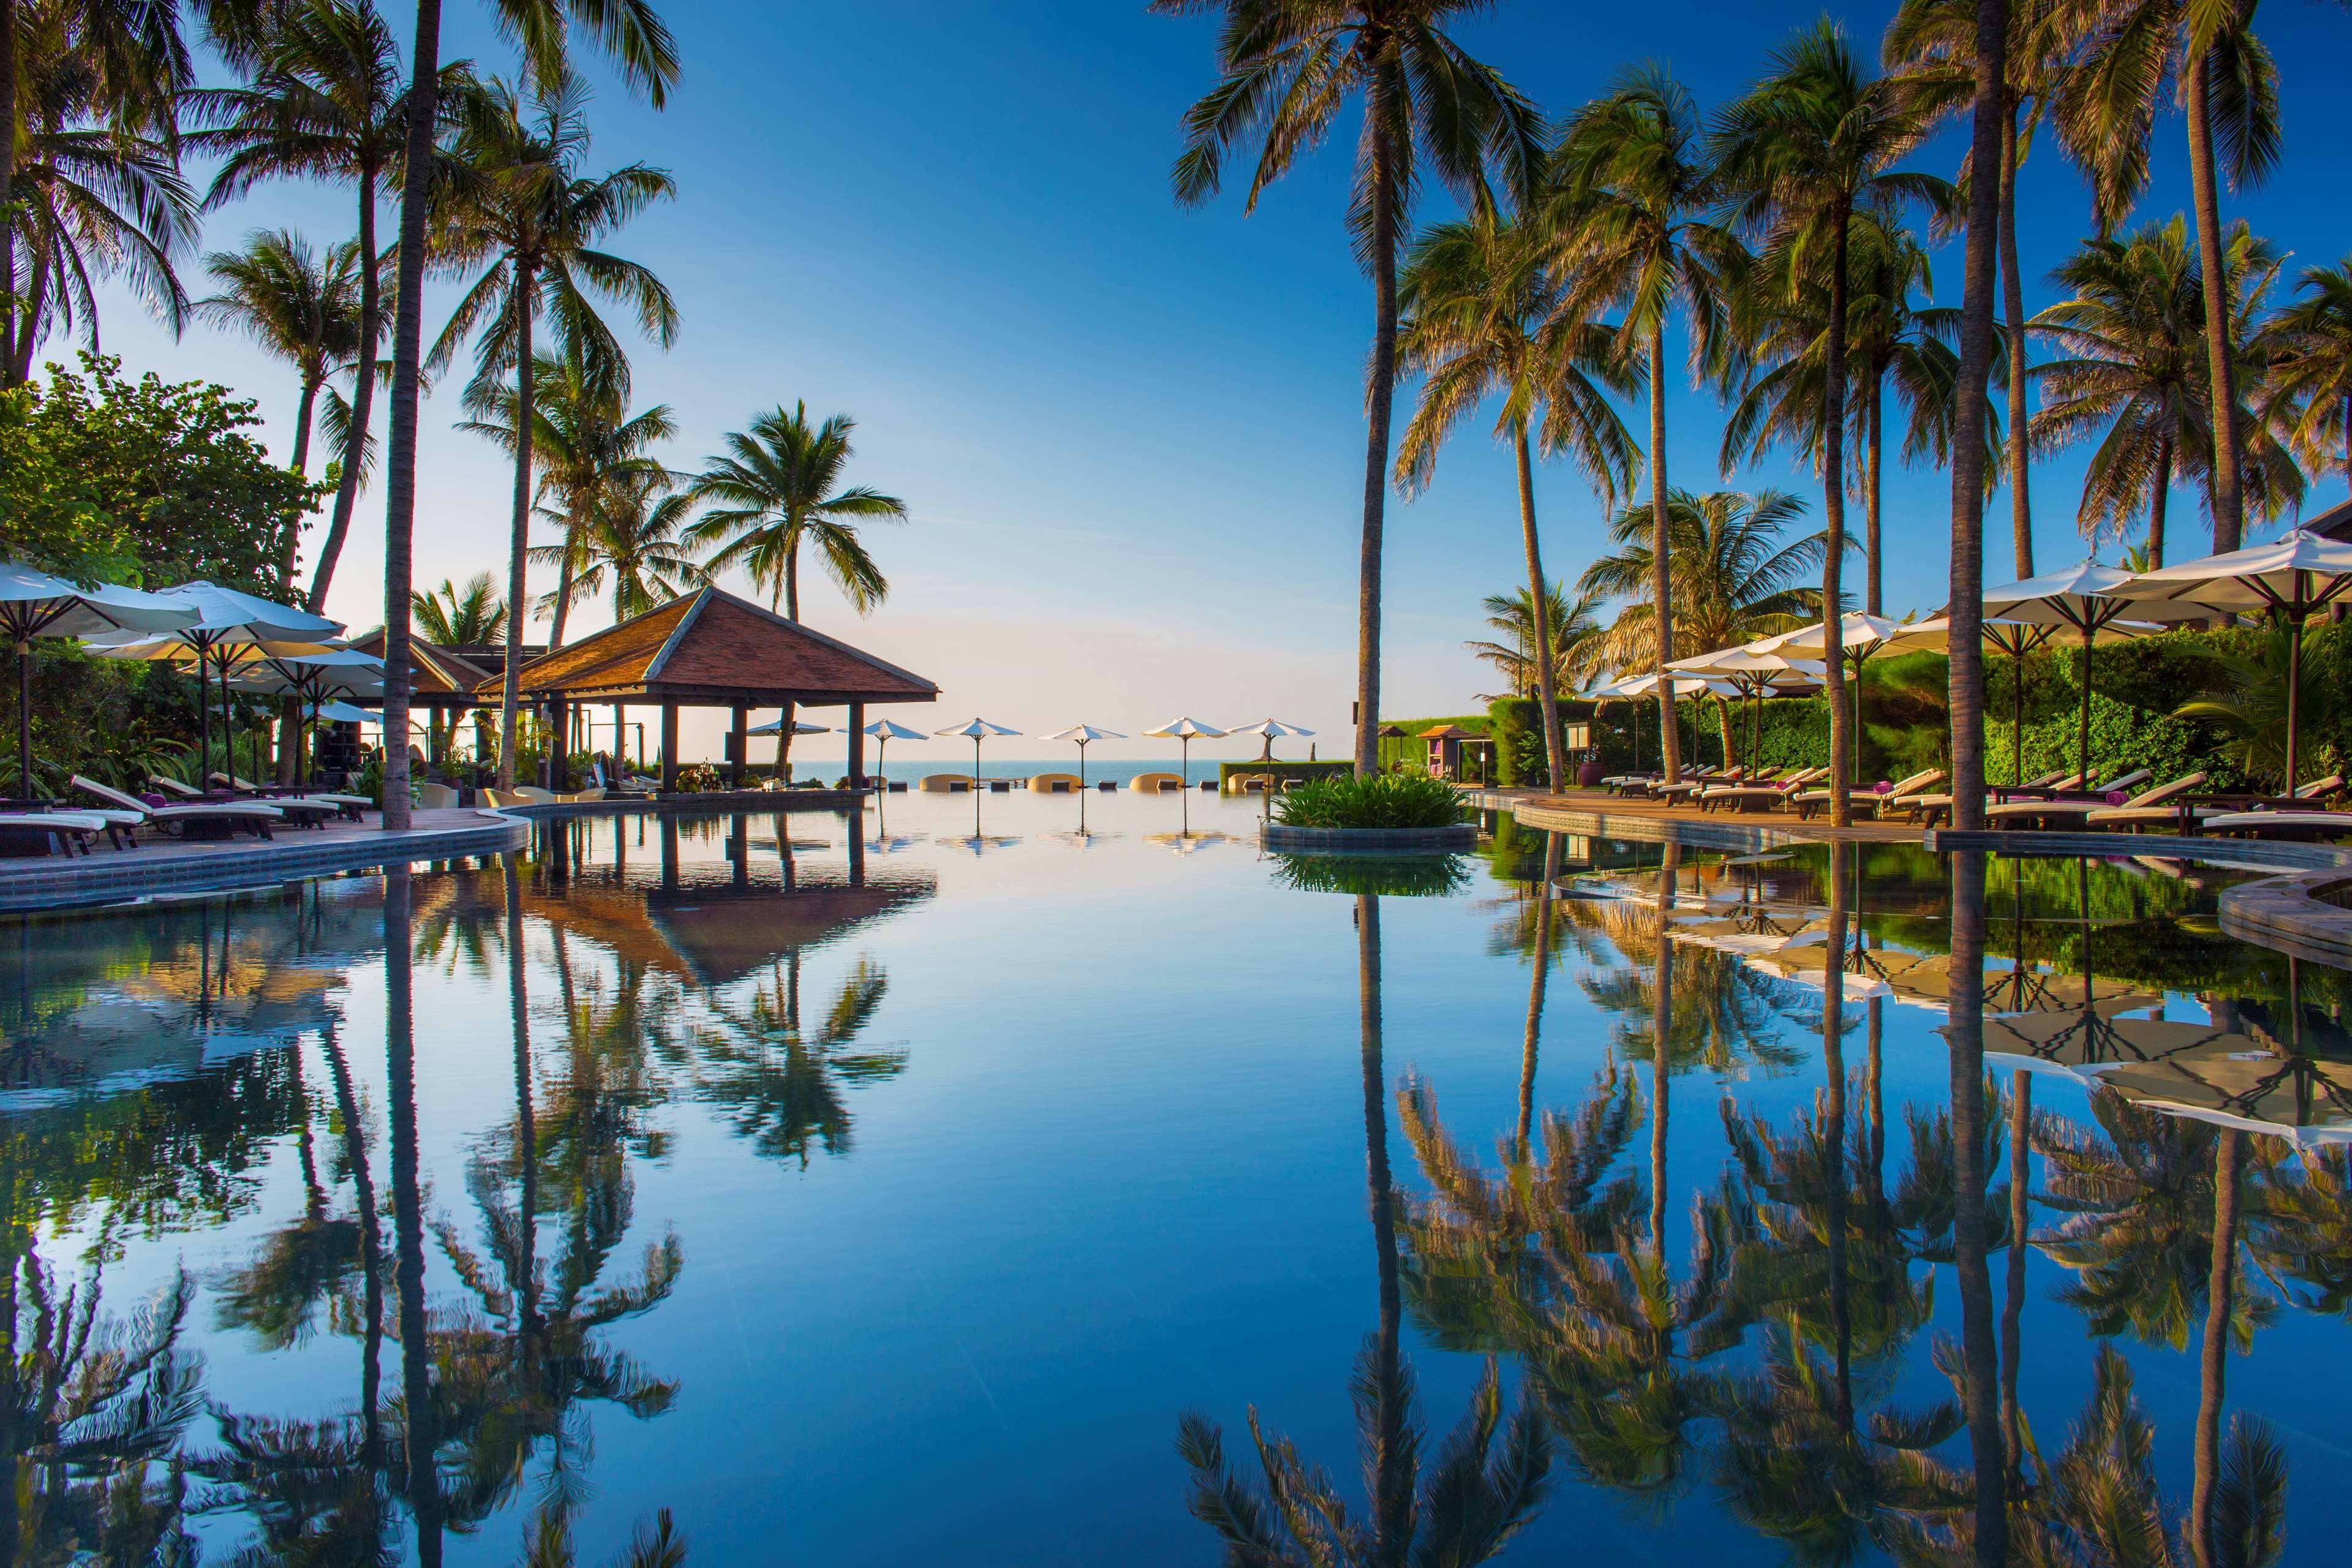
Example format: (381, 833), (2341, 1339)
(2032, 216), (2302, 567)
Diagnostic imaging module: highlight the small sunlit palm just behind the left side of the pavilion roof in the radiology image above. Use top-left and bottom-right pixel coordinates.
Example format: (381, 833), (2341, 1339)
(461, 341), (677, 649)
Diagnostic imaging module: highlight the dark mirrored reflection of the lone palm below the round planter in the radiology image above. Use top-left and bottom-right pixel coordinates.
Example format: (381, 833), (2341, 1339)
(1176, 893), (1552, 1568)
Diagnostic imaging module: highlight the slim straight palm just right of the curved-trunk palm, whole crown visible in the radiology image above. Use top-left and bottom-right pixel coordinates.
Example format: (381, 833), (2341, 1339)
(1552, 64), (1738, 780)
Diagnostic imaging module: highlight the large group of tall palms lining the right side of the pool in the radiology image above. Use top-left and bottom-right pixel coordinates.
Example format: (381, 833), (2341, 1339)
(1157, 0), (2352, 832)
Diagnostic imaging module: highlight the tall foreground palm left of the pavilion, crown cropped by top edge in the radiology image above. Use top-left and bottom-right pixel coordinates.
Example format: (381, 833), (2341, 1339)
(371, 0), (677, 832)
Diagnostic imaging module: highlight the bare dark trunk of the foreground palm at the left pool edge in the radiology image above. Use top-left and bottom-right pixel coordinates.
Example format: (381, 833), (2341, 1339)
(379, 0), (447, 832)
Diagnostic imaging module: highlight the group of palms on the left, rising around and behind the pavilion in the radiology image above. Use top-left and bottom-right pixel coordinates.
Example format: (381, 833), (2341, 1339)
(13, 0), (905, 809)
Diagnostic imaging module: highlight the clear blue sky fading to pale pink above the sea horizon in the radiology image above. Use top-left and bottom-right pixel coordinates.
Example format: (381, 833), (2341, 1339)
(69, 0), (2352, 757)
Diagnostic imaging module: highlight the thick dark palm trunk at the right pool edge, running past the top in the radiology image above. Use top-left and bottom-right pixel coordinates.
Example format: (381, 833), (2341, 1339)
(1945, 0), (2003, 827)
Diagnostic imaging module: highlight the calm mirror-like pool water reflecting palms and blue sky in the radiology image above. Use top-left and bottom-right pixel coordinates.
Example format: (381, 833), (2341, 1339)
(0, 794), (2352, 1566)
